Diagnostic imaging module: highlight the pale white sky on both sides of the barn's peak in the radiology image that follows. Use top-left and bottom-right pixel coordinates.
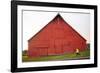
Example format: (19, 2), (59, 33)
(23, 11), (90, 50)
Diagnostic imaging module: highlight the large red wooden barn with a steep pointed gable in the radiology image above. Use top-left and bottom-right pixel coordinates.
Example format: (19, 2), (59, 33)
(28, 14), (86, 57)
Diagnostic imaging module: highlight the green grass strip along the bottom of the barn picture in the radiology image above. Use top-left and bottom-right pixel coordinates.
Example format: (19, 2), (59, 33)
(22, 49), (90, 62)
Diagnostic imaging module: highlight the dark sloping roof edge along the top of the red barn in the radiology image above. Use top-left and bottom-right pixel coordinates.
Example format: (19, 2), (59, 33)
(28, 13), (86, 41)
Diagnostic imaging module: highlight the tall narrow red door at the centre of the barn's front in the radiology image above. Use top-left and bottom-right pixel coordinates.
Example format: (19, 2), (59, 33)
(54, 39), (63, 55)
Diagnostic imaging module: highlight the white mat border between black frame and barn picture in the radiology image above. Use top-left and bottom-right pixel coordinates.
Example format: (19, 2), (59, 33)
(17, 5), (94, 68)
